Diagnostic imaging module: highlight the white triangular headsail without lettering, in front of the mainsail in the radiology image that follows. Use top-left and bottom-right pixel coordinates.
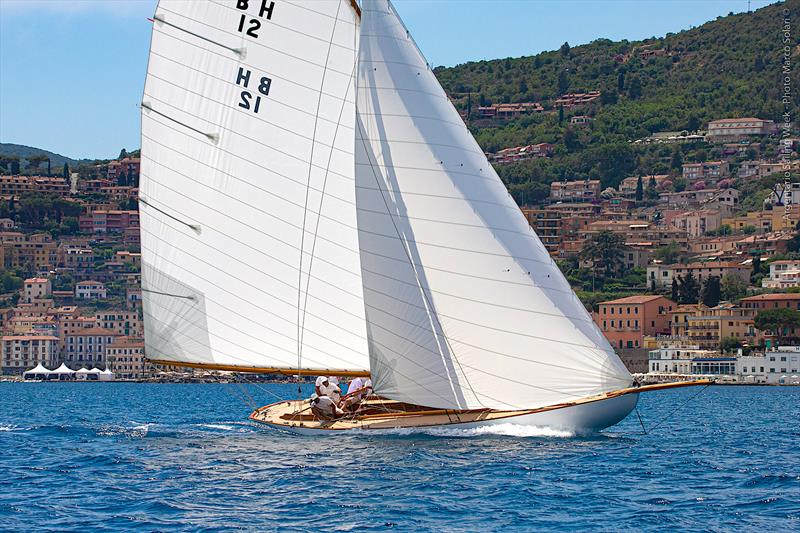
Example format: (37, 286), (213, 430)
(356, 0), (631, 409)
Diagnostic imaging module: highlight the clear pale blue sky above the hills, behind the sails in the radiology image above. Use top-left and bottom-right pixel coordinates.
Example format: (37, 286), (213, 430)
(0, 0), (774, 159)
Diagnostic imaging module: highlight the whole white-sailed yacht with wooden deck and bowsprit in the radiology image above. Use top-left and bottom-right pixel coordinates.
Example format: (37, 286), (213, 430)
(140, 0), (708, 433)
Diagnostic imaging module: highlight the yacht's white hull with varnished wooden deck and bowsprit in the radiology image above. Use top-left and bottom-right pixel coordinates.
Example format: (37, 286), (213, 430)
(250, 380), (711, 434)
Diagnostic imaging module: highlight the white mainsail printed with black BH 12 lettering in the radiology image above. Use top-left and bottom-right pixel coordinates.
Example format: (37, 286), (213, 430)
(140, 0), (369, 370)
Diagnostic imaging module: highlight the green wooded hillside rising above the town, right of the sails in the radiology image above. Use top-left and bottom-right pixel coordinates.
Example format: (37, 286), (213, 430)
(435, 0), (800, 201)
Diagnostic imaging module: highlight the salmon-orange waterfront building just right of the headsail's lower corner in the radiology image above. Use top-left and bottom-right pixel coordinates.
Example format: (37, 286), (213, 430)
(595, 295), (676, 348)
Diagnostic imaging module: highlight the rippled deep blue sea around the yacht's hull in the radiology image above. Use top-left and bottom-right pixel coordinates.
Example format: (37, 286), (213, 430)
(0, 383), (800, 532)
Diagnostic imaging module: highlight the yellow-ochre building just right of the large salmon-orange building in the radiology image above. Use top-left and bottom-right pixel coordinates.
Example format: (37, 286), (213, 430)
(687, 302), (756, 350)
